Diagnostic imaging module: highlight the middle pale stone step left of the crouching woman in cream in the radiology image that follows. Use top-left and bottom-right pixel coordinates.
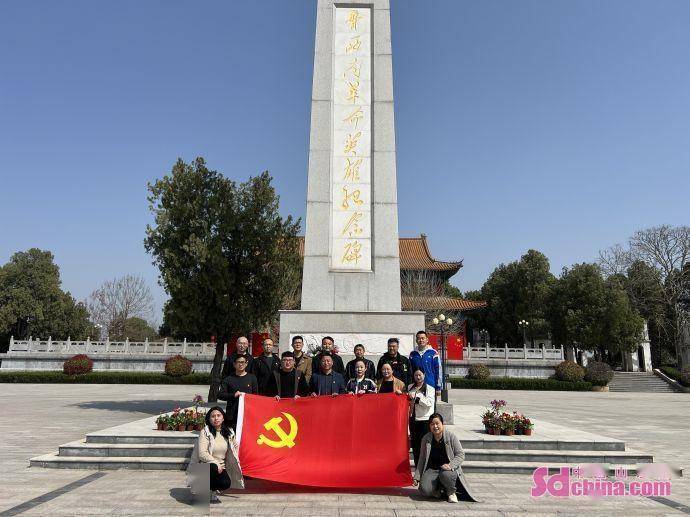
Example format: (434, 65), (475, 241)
(58, 440), (193, 458)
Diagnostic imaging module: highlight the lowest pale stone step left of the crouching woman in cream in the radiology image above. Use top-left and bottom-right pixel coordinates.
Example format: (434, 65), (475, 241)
(29, 454), (189, 470)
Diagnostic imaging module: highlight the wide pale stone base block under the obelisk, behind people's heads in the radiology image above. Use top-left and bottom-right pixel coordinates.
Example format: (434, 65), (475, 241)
(280, 311), (424, 359)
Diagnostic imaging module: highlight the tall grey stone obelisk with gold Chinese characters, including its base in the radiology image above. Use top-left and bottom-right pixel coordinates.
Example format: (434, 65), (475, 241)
(280, 0), (424, 355)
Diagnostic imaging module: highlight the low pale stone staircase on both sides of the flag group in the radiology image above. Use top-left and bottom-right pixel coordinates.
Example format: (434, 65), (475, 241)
(30, 406), (653, 474)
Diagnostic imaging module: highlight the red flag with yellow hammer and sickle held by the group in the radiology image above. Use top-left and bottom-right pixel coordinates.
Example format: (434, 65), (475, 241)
(237, 393), (412, 487)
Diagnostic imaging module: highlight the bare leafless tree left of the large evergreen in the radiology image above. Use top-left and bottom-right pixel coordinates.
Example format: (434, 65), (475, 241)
(88, 275), (153, 338)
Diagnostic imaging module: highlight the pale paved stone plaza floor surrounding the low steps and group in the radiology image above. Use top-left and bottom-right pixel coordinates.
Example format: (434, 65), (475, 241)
(0, 384), (690, 517)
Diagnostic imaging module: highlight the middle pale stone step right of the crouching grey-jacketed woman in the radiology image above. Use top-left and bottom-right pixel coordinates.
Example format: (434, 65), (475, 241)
(464, 449), (654, 464)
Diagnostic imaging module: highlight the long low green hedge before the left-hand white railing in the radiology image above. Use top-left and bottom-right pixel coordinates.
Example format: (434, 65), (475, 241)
(0, 370), (211, 386)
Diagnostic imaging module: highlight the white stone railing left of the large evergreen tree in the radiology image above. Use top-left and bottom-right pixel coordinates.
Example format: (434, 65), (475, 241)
(9, 337), (216, 356)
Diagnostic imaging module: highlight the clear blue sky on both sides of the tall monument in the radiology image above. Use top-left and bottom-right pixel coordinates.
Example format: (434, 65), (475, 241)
(0, 0), (690, 322)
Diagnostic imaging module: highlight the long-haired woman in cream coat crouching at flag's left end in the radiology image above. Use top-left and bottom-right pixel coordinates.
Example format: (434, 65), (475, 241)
(190, 406), (244, 497)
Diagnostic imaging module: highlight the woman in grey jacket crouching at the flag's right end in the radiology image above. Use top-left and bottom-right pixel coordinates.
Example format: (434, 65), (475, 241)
(414, 413), (479, 503)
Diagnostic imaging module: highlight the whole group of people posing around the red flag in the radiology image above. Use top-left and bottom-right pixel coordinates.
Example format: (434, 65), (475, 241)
(199, 330), (473, 502)
